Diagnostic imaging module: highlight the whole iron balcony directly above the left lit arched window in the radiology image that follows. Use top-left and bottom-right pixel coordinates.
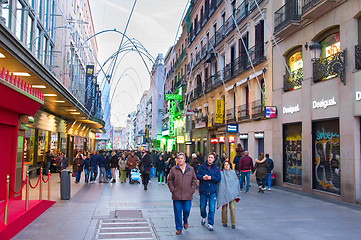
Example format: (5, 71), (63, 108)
(274, 0), (301, 37)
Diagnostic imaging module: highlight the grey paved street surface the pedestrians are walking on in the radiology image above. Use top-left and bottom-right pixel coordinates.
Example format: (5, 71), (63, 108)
(13, 174), (361, 240)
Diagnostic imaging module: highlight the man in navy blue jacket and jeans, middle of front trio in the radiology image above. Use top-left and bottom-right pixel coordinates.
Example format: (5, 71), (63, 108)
(197, 153), (221, 231)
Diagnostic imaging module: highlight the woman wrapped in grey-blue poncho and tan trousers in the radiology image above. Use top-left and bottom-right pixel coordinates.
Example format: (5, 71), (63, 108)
(217, 161), (240, 229)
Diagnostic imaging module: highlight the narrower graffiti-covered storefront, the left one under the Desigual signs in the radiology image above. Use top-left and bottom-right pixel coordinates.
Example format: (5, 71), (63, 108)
(283, 123), (302, 186)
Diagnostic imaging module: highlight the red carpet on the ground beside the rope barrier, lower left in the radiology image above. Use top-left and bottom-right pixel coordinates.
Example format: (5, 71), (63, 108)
(0, 199), (55, 240)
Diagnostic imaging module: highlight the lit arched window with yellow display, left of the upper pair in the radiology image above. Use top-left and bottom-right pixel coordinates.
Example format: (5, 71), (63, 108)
(283, 48), (303, 92)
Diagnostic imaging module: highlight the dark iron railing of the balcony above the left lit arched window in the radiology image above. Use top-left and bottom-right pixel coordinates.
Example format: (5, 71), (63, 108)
(274, 0), (301, 32)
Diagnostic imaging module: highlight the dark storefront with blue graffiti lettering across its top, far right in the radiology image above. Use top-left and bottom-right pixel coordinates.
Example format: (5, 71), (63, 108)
(312, 120), (341, 195)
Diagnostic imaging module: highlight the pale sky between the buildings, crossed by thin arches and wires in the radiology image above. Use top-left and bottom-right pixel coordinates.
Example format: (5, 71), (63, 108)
(89, 0), (188, 127)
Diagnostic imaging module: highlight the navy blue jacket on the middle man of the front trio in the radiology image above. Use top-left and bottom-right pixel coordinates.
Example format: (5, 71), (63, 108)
(196, 162), (221, 194)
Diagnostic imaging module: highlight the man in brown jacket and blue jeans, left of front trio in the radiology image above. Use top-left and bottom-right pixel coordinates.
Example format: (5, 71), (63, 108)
(168, 153), (197, 235)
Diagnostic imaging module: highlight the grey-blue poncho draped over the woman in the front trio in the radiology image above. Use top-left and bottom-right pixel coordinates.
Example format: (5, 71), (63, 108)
(217, 169), (240, 209)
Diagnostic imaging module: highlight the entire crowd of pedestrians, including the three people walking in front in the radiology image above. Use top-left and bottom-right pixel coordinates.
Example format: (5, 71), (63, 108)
(46, 144), (274, 235)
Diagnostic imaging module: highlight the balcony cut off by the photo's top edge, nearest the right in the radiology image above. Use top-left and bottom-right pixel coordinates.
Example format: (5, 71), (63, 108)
(302, 0), (342, 19)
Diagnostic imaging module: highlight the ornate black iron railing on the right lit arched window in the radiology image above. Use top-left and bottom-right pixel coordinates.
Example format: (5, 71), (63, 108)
(313, 51), (346, 84)
